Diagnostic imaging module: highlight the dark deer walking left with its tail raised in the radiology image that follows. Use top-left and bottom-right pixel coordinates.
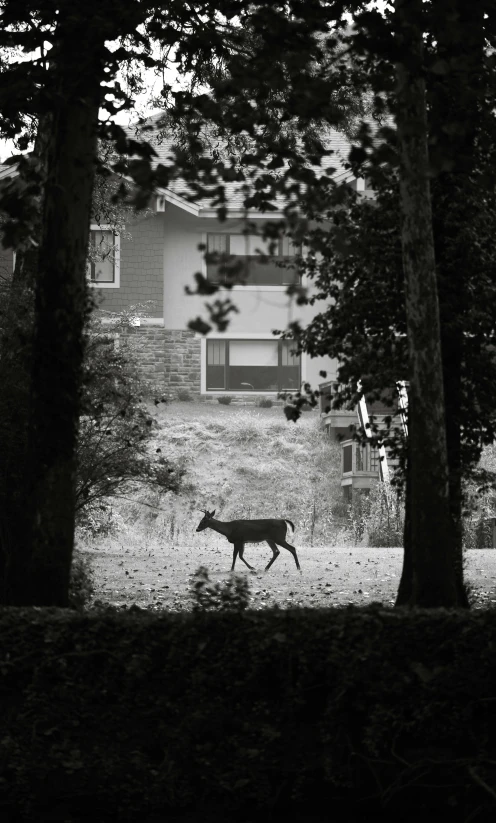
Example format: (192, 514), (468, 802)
(196, 509), (301, 572)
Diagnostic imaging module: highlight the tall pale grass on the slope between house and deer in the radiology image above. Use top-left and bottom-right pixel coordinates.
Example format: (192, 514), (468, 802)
(77, 403), (346, 549)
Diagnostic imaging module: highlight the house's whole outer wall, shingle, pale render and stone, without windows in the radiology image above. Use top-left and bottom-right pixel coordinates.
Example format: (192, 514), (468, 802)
(91, 203), (336, 397)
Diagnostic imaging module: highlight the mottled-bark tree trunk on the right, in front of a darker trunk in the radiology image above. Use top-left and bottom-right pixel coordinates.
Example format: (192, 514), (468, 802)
(396, 0), (458, 607)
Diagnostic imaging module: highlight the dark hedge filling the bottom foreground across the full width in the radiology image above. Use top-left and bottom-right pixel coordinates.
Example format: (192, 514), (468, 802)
(0, 606), (496, 823)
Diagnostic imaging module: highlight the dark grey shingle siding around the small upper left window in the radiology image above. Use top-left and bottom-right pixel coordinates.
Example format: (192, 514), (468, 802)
(94, 214), (164, 317)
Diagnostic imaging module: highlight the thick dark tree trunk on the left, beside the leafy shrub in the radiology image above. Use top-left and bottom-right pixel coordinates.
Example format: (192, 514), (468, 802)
(9, 13), (104, 606)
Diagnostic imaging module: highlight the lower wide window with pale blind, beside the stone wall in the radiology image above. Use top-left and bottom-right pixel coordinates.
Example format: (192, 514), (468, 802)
(206, 340), (301, 392)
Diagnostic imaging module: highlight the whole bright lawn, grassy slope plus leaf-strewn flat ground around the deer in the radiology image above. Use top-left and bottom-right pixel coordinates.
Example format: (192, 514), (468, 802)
(79, 403), (496, 611)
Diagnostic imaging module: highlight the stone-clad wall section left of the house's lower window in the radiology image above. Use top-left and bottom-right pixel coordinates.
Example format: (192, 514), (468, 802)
(120, 326), (201, 397)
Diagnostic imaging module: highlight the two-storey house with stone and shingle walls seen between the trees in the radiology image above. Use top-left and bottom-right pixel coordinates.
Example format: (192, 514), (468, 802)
(0, 117), (374, 399)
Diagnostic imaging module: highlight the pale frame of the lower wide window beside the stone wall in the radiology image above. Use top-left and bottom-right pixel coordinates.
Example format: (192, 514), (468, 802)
(201, 334), (305, 396)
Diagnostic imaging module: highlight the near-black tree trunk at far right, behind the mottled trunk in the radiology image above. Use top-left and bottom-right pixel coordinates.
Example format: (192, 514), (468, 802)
(429, 0), (487, 607)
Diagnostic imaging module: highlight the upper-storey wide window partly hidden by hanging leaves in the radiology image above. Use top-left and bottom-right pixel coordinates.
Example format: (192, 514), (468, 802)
(207, 232), (300, 286)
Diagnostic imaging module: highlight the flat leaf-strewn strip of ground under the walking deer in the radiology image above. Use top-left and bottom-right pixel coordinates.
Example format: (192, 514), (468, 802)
(86, 544), (496, 611)
